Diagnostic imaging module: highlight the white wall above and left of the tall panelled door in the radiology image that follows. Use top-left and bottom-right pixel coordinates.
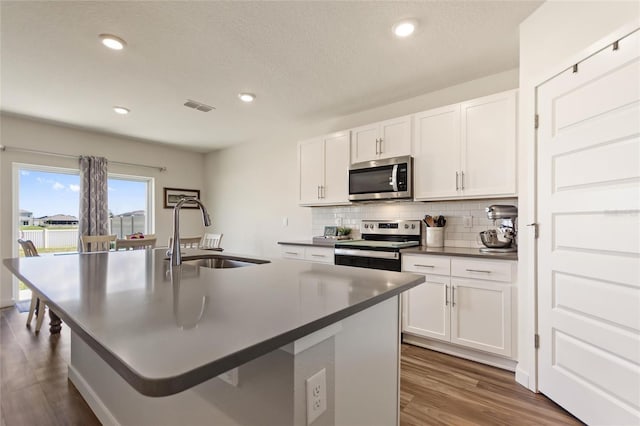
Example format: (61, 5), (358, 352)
(516, 1), (640, 390)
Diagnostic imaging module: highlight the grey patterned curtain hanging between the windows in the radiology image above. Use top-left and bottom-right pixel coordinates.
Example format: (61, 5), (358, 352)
(78, 156), (109, 251)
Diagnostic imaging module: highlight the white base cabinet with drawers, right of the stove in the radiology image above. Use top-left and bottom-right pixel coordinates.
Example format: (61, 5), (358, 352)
(402, 255), (515, 357)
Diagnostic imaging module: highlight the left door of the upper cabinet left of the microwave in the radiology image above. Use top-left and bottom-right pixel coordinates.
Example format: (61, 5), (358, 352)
(298, 138), (324, 204)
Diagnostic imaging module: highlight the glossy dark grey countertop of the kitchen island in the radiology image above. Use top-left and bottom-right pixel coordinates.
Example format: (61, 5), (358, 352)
(4, 249), (424, 396)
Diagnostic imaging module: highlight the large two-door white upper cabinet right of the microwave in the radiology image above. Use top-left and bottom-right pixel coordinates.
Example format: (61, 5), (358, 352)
(414, 90), (517, 200)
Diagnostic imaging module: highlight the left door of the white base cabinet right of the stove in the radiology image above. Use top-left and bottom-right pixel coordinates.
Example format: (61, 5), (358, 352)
(402, 275), (451, 342)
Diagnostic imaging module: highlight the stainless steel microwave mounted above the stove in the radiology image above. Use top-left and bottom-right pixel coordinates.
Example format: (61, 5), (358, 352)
(349, 155), (413, 201)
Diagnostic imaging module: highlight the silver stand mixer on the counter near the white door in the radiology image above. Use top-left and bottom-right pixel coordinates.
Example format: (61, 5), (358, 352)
(480, 204), (518, 253)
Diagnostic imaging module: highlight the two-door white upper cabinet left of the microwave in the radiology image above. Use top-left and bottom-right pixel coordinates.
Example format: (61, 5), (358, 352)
(298, 132), (349, 206)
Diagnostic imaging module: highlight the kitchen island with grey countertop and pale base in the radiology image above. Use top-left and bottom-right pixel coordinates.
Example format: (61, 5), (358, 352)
(4, 249), (424, 426)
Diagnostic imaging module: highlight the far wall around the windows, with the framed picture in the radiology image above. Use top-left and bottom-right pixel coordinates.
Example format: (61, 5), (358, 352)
(0, 115), (205, 306)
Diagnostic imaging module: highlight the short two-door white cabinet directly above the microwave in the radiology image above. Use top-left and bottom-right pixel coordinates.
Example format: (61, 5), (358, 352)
(351, 115), (411, 163)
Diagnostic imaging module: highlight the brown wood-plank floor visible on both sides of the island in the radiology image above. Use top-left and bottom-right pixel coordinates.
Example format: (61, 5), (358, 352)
(0, 307), (580, 426)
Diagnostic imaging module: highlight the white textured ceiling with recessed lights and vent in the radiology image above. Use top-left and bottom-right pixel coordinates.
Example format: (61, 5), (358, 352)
(0, 1), (542, 151)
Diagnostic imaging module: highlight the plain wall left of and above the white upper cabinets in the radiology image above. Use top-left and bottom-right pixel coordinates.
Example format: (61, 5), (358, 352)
(204, 69), (518, 257)
